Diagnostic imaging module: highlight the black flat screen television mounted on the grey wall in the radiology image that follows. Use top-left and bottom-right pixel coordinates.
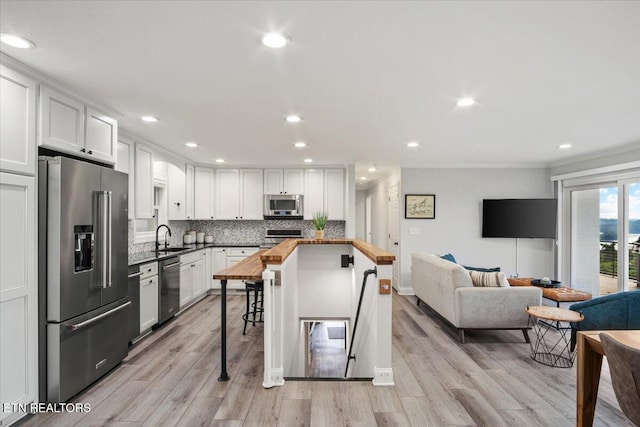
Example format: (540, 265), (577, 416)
(482, 199), (558, 239)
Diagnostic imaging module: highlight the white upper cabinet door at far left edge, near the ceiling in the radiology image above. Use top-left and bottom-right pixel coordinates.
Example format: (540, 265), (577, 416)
(0, 65), (37, 175)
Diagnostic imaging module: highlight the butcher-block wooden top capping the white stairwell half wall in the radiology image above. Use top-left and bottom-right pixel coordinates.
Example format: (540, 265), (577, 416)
(260, 239), (395, 266)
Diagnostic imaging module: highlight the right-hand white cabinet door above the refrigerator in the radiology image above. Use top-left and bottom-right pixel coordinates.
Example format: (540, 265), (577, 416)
(85, 107), (118, 163)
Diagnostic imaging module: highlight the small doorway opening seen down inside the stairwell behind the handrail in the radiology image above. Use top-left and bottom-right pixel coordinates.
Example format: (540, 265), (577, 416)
(304, 320), (348, 378)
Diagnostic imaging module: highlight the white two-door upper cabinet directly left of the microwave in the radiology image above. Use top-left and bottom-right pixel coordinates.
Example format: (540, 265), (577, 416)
(216, 169), (263, 219)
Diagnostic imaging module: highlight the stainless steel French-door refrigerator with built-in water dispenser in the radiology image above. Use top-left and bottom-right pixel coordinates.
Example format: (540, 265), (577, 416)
(38, 157), (131, 402)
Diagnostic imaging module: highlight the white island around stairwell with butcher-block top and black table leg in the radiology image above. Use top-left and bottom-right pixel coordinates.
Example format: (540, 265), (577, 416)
(213, 239), (395, 388)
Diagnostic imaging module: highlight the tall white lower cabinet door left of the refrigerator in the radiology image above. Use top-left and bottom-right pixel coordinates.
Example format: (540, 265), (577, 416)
(0, 172), (38, 425)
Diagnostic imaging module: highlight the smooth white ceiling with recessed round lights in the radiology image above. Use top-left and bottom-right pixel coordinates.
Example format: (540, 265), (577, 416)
(0, 0), (640, 184)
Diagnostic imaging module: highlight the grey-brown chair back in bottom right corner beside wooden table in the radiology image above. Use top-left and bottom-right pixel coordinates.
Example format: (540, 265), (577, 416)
(600, 332), (640, 426)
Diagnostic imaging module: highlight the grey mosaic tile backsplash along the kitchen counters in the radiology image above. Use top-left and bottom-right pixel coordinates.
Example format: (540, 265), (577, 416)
(129, 220), (345, 253)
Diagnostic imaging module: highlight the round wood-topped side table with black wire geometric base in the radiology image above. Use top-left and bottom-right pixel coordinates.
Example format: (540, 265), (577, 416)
(526, 305), (584, 368)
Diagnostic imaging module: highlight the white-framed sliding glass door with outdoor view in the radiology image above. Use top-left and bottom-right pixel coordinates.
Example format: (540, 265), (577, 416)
(565, 180), (640, 295)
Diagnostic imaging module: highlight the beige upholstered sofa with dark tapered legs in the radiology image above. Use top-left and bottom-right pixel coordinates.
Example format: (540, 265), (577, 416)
(411, 253), (542, 343)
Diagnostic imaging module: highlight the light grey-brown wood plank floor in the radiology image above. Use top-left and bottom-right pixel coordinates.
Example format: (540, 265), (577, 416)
(18, 295), (631, 427)
